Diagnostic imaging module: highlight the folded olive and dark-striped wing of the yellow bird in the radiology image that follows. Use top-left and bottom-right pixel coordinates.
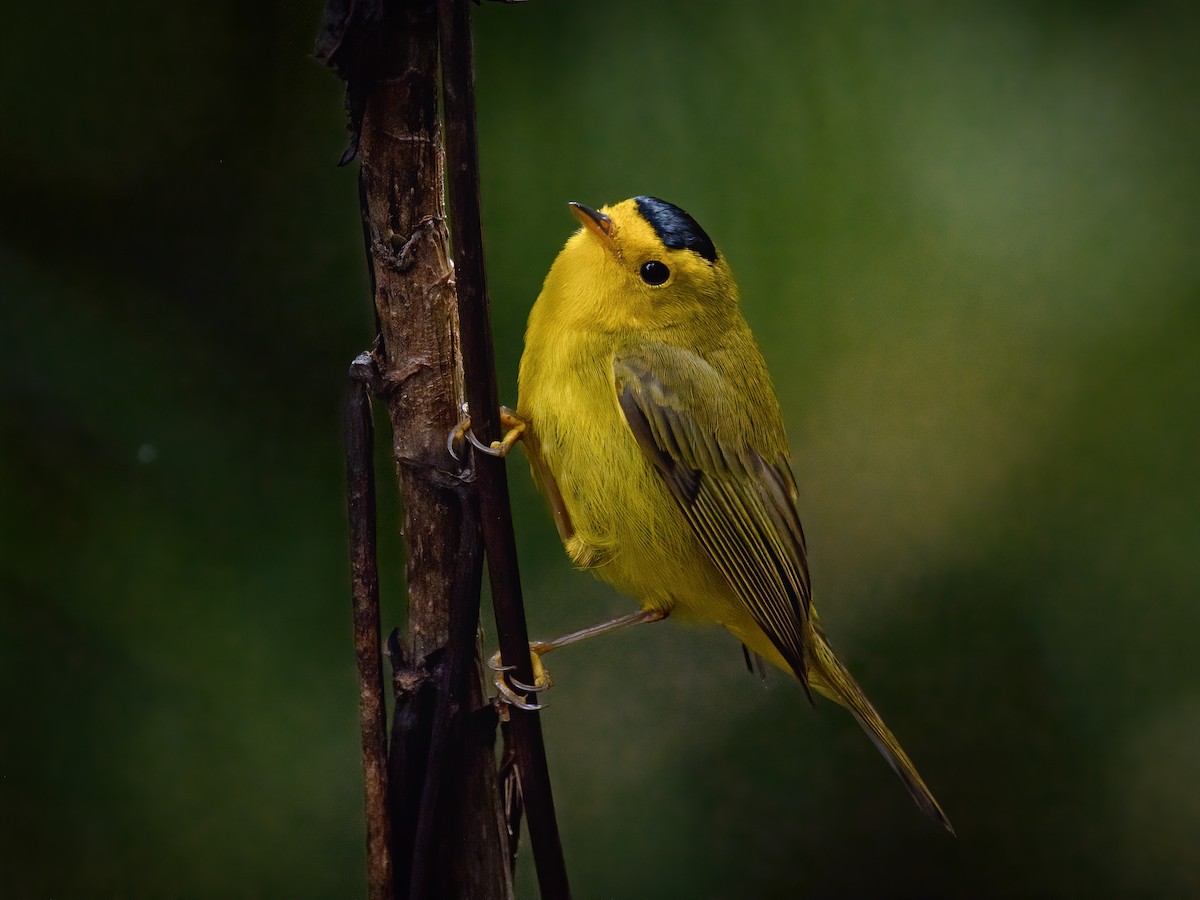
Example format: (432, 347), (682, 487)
(613, 344), (811, 698)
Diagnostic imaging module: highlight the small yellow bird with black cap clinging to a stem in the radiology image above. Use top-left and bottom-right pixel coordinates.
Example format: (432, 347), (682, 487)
(467, 197), (954, 833)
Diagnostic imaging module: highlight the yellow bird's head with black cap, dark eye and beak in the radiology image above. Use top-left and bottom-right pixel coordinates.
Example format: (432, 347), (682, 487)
(538, 197), (738, 332)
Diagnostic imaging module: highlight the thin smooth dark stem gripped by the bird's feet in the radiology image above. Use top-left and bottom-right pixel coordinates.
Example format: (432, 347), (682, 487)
(438, 0), (570, 900)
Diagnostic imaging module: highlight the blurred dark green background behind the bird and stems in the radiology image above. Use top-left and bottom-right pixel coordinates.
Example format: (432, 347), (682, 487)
(0, 0), (1200, 898)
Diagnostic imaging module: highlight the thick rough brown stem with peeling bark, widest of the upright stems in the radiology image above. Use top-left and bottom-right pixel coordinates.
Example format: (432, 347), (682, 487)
(318, 0), (523, 900)
